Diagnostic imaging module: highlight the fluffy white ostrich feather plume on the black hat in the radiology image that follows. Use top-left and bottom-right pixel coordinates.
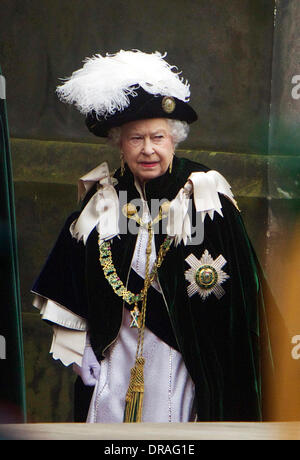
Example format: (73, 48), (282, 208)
(56, 50), (190, 117)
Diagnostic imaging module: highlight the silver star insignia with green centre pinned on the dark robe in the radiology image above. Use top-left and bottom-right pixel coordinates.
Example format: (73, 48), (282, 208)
(184, 249), (229, 299)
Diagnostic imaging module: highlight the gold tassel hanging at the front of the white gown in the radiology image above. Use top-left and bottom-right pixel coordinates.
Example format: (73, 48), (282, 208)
(124, 356), (145, 423)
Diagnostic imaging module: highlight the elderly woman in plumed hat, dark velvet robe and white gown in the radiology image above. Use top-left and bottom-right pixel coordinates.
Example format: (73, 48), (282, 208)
(32, 51), (274, 422)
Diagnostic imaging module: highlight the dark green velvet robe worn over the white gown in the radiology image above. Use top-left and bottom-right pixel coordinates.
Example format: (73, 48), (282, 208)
(33, 157), (272, 421)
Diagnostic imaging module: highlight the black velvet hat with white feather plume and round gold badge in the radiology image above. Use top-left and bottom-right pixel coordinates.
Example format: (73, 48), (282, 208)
(57, 50), (197, 137)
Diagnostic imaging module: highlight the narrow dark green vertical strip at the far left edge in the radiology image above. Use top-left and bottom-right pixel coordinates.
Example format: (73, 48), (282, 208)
(0, 68), (26, 422)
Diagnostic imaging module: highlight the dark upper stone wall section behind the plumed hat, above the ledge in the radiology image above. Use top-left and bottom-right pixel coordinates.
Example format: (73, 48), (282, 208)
(0, 0), (274, 153)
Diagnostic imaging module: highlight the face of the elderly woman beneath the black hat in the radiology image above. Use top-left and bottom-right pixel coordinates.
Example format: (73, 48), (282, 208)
(120, 118), (174, 183)
